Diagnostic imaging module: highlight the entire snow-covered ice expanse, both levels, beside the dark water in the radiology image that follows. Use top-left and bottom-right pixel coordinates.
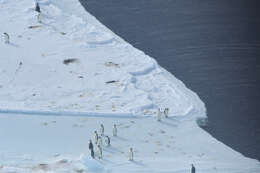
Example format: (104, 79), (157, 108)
(0, 0), (260, 173)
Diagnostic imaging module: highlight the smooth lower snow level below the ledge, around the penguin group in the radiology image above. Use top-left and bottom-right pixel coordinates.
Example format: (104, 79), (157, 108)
(0, 114), (259, 173)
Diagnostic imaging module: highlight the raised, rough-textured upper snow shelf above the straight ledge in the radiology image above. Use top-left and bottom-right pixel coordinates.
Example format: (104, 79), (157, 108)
(0, 0), (206, 119)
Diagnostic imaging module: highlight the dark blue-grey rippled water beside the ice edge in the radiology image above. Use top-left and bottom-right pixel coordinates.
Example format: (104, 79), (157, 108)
(78, 0), (260, 160)
